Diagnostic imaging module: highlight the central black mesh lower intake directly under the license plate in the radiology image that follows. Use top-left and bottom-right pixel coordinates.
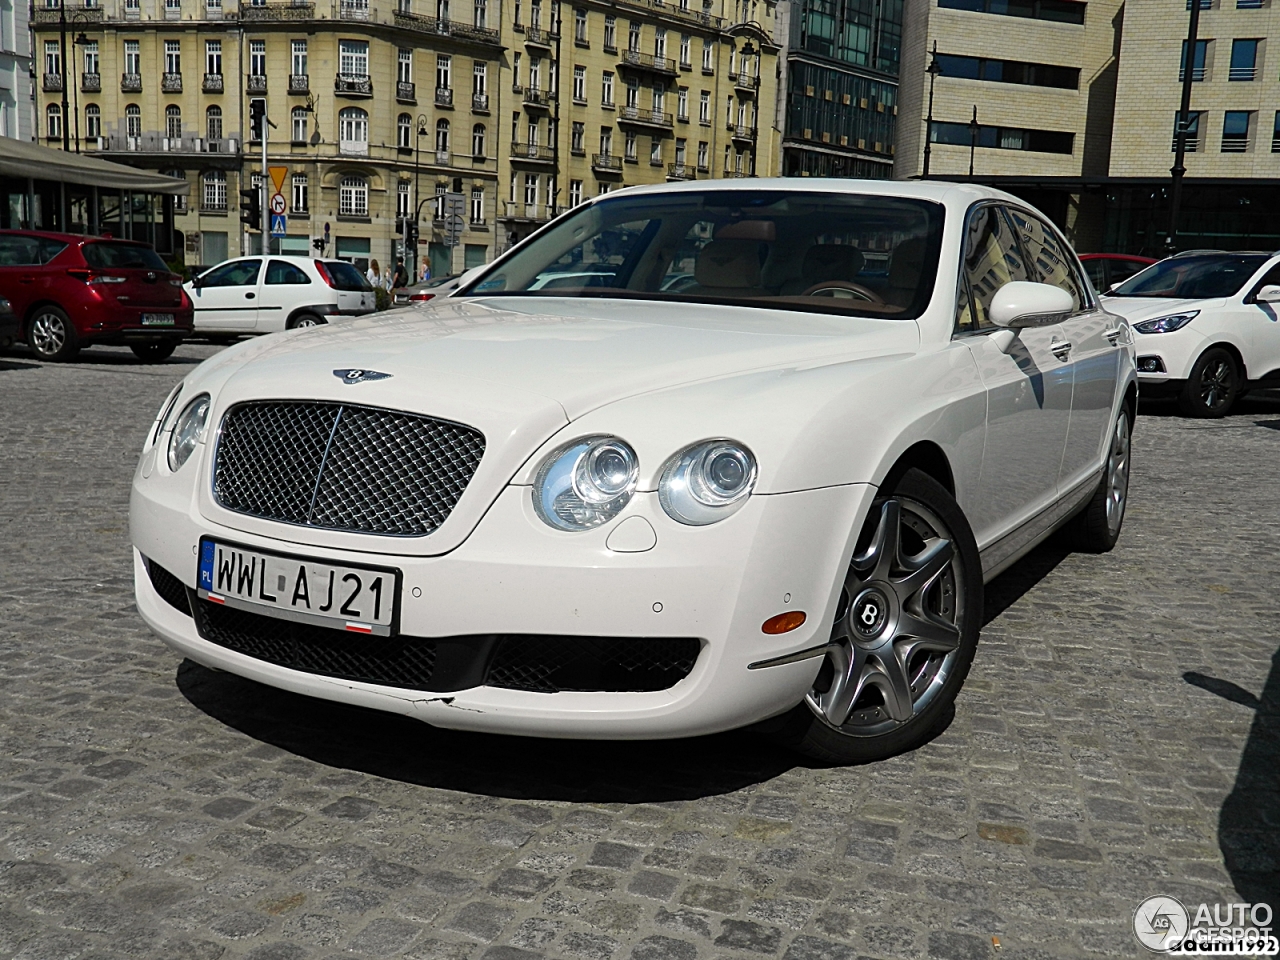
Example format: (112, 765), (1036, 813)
(195, 600), (435, 690)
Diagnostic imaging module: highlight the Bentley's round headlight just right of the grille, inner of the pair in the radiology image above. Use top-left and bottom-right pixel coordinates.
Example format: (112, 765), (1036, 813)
(534, 436), (640, 530)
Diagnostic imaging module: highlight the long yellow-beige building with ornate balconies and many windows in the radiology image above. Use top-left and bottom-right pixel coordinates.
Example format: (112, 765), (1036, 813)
(35, 0), (777, 275)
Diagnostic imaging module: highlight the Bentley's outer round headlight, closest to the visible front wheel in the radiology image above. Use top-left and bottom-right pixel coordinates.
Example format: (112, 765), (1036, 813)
(658, 440), (755, 526)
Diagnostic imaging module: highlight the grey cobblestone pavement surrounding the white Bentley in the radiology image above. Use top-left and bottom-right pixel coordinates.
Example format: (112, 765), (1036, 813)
(0, 347), (1280, 960)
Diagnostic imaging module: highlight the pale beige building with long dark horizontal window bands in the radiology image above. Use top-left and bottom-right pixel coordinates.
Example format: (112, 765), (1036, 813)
(893, 0), (1123, 245)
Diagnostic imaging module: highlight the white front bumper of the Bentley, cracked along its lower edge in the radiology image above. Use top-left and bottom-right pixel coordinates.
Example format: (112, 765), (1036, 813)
(131, 474), (874, 739)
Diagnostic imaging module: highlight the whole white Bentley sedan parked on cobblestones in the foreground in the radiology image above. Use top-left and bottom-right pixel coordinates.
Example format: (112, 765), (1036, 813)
(132, 180), (1137, 763)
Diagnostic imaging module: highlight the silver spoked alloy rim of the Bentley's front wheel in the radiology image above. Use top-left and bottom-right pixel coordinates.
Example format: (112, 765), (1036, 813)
(806, 499), (964, 736)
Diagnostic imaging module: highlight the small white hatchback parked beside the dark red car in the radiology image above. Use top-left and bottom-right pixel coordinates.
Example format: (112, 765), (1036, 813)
(186, 256), (378, 339)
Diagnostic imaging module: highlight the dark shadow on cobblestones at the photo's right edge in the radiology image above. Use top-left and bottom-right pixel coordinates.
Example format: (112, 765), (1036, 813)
(1183, 649), (1280, 913)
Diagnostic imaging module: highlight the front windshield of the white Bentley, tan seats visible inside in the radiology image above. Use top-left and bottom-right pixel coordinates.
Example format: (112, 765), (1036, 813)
(465, 189), (943, 319)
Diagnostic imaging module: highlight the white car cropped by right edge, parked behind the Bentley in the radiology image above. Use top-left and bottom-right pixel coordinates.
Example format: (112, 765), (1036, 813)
(1103, 251), (1280, 417)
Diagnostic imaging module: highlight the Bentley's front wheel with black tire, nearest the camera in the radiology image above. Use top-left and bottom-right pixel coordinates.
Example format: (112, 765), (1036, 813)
(771, 468), (983, 764)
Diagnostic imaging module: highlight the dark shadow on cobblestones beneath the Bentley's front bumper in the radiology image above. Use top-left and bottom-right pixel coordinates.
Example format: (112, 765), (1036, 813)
(177, 660), (803, 804)
